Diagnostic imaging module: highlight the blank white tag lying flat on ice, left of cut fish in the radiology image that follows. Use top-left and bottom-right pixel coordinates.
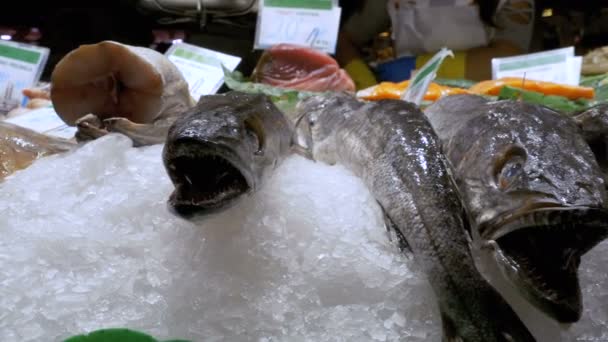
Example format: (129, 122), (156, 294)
(5, 107), (77, 139)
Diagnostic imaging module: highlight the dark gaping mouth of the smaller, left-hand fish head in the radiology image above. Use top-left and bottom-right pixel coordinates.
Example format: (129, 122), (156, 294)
(167, 153), (250, 217)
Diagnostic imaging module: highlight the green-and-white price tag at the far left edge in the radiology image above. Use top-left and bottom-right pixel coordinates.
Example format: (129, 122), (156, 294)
(0, 40), (49, 114)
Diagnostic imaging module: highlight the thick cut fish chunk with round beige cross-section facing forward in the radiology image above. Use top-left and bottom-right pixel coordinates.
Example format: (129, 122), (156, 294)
(50, 41), (196, 146)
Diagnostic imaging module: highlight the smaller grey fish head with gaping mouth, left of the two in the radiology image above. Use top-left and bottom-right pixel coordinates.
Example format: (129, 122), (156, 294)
(162, 91), (293, 217)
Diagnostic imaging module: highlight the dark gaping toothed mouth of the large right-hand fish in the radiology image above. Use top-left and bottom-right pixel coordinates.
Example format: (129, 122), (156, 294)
(482, 206), (608, 323)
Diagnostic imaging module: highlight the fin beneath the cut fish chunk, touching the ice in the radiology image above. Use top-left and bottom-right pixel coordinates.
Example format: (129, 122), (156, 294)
(103, 118), (171, 146)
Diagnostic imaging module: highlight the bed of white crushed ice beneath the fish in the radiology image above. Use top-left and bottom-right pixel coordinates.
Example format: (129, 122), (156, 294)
(0, 135), (608, 342)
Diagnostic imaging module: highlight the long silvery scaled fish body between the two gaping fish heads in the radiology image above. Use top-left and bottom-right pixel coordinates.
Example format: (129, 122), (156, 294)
(294, 92), (535, 342)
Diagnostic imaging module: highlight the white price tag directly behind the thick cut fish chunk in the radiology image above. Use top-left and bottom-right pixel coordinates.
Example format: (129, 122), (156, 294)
(165, 43), (241, 101)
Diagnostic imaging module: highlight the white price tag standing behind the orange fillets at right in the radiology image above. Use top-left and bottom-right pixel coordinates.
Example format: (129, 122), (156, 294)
(492, 47), (582, 85)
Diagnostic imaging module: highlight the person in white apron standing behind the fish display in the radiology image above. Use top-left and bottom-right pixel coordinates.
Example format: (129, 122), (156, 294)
(336, 0), (535, 89)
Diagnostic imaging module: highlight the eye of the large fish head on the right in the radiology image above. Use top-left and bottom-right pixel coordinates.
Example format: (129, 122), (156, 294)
(494, 146), (527, 190)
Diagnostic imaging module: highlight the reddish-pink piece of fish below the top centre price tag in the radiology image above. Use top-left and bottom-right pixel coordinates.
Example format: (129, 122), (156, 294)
(251, 44), (355, 92)
